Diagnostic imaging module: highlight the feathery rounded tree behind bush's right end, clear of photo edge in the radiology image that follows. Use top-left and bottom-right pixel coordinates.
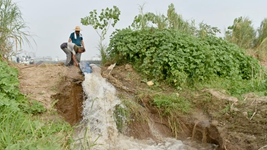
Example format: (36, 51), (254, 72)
(225, 17), (256, 49)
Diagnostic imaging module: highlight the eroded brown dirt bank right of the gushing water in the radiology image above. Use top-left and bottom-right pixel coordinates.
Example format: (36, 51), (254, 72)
(102, 65), (267, 150)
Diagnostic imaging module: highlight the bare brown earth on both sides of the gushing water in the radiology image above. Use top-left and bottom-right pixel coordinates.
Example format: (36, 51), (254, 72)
(17, 64), (267, 150)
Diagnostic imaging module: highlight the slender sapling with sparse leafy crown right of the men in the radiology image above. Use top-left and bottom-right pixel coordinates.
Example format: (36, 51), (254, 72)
(81, 6), (121, 63)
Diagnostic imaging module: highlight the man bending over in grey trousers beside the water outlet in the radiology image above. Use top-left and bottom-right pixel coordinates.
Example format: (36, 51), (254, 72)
(60, 43), (85, 67)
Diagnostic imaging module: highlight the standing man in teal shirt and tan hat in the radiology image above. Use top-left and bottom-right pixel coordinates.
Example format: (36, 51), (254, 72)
(68, 26), (85, 62)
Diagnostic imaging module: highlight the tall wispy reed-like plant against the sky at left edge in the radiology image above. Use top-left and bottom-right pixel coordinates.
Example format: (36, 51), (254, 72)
(0, 0), (30, 58)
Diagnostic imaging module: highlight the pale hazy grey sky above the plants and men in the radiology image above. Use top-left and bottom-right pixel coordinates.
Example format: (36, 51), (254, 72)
(13, 0), (267, 60)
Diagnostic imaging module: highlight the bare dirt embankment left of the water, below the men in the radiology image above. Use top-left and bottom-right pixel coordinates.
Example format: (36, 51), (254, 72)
(18, 64), (83, 125)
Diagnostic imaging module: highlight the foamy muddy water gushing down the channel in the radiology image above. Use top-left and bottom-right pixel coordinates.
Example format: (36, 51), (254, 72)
(73, 66), (218, 150)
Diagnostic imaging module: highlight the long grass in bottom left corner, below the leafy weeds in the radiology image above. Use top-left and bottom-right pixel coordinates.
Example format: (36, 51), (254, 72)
(0, 109), (72, 150)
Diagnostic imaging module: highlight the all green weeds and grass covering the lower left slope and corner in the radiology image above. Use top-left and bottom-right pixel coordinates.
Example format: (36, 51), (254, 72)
(0, 61), (71, 150)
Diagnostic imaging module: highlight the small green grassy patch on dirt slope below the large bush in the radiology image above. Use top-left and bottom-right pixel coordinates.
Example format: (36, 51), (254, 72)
(153, 93), (192, 115)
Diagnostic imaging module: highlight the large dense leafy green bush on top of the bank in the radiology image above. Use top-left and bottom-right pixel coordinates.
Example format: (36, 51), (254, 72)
(108, 29), (265, 91)
